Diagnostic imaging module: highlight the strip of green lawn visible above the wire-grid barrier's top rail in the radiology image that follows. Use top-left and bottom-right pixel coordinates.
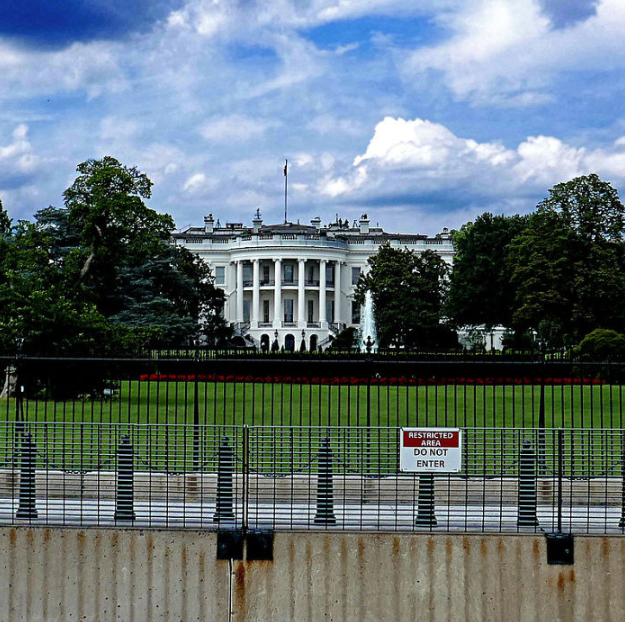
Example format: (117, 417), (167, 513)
(0, 381), (625, 428)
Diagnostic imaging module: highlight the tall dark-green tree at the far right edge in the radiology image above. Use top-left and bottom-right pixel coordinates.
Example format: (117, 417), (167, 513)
(509, 175), (625, 346)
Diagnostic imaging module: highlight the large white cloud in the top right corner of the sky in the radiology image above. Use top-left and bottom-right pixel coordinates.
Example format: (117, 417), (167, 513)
(403, 0), (625, 106)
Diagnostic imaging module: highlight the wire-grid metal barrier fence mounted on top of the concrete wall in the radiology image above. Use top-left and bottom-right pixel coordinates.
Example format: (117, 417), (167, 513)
(0, 422), (625, 534)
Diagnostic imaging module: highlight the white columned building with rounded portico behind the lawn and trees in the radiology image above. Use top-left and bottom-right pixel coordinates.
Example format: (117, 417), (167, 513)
(173, 211), (454, 350)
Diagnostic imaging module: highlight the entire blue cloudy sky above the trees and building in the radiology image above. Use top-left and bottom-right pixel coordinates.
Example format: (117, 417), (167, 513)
(0, 0), (625, 233)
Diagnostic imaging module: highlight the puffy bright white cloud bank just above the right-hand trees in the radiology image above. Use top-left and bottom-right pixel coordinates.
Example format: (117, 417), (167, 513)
(319, 117), (625, 203)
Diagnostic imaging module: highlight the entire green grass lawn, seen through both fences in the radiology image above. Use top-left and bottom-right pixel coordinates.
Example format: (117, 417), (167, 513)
(0, 381), (625, 475)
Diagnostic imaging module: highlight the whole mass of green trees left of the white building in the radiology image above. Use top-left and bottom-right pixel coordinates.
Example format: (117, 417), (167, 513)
(0, 157), (230, 354)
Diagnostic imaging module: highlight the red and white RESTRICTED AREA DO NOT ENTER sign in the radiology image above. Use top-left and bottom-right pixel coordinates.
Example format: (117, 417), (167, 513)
(399, 428), (462, 473)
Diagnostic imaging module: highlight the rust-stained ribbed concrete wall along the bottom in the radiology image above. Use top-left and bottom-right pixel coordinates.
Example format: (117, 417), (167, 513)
(0, 527), (625, 622)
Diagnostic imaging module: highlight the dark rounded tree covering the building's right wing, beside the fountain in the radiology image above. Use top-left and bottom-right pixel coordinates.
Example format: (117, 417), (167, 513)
(356, 244), (449, 348)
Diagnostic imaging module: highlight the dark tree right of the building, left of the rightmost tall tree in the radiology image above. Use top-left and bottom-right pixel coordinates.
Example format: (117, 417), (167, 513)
(446, 212), (527, 328)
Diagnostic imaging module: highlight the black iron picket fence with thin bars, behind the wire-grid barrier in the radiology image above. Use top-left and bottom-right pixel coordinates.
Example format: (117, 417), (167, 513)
(0, 353), (625, 428)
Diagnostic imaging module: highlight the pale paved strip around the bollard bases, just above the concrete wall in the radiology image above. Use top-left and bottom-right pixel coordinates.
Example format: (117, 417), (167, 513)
(0, 498), (625, 535)
